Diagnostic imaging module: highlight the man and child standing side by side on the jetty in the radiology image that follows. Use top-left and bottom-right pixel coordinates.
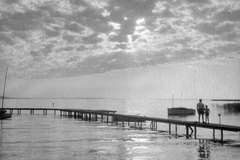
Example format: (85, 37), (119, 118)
(197, 99), (210, 123)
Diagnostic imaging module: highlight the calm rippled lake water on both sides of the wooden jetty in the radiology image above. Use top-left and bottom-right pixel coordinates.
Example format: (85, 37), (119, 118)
(0, 99), (240, 160)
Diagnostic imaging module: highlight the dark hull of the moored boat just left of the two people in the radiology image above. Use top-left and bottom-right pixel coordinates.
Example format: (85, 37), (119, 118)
(168, 107), (196, 115)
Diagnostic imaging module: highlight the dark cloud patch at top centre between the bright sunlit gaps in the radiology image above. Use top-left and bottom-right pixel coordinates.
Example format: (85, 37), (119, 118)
(108, 1), (158, 42)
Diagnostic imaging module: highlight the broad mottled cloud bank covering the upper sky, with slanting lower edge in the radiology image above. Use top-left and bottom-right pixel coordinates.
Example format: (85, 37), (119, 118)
(0, 0), (240, 78)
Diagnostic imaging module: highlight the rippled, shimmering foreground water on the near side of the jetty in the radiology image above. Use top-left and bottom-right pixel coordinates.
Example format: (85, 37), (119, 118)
(0, 114), (239, 160)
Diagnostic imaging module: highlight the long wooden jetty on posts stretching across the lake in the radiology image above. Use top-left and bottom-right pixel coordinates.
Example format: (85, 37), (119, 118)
(4, 108), (240, 142)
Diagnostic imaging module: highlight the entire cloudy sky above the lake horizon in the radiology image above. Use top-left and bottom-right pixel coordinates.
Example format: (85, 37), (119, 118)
(0, 0), (240, 99)
